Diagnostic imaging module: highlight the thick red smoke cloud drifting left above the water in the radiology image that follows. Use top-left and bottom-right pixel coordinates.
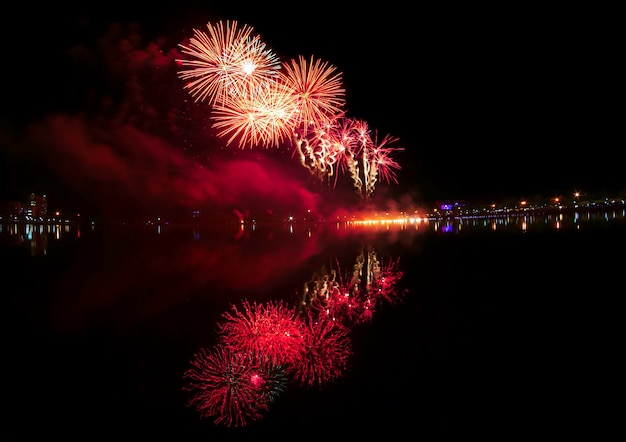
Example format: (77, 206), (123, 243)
(29, 115), (319, 221)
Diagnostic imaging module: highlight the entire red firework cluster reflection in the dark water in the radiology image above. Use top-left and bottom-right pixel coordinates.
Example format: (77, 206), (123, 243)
(183, 247), (406, 427)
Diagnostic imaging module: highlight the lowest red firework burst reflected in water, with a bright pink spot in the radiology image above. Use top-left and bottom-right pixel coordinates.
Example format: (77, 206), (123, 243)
(183, 345), (286, 427)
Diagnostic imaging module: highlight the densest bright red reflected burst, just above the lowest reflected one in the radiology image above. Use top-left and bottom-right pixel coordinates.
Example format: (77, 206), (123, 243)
(218, 301), (304, 365)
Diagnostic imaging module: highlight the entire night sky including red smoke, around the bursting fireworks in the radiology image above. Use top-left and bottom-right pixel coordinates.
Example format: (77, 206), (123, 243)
(0, 1), (625, 218)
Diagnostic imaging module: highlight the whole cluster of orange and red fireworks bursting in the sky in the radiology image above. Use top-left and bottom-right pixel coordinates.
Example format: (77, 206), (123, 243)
(179, 21), (403, 199)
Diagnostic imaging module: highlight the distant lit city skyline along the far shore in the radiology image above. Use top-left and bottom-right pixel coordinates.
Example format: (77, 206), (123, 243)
(0, 186), (626, 226)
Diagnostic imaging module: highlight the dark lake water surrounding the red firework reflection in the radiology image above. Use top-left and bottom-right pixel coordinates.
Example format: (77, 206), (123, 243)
(0, 212), (626, 441)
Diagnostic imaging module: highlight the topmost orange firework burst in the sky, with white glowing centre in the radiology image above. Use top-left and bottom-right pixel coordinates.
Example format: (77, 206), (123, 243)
(178, 21), (281, 106)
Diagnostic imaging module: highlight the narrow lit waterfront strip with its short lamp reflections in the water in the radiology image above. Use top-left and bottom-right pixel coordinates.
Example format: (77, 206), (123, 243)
(0, 202), (626, 255)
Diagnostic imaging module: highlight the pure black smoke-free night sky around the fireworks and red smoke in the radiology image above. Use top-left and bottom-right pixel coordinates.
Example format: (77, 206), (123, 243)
(0, 1), (626, 212)
